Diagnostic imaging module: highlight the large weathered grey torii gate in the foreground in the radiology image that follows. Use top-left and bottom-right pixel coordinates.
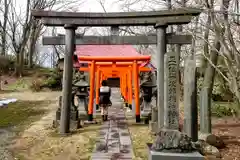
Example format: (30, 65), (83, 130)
(31, 8), (202, 134)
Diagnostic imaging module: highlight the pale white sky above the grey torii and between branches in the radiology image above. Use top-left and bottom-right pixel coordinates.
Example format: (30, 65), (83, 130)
(16, 0), (200, 66)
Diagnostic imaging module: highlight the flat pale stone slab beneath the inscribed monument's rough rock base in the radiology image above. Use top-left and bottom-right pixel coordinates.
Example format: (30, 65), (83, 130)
(147, 144), (204, 160)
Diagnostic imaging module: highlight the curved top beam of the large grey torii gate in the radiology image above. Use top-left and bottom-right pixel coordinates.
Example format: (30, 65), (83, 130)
(32, 8), (201, 27)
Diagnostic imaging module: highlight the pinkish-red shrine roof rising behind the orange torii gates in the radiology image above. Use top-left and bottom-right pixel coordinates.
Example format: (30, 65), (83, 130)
(74, 45), (155, 69)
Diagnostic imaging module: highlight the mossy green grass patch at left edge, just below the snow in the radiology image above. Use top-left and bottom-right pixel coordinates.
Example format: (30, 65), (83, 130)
(0, 101), (48, 128)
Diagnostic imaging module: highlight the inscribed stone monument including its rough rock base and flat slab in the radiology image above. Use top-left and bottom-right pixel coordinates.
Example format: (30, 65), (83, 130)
(148, 52), (204, 160)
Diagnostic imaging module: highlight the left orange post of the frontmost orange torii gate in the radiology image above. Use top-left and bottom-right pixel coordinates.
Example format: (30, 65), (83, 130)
(88, 60), (95, 121)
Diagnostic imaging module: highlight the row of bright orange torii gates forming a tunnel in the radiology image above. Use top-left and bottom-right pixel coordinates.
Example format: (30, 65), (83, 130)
(79, 56), (151, 122)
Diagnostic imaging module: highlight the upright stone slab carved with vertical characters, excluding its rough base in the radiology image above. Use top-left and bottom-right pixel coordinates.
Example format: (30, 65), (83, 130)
(164, 52), (179, 130)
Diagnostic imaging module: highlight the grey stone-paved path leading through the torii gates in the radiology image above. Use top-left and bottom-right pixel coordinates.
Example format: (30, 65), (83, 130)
(92, 98), (133, 160)
